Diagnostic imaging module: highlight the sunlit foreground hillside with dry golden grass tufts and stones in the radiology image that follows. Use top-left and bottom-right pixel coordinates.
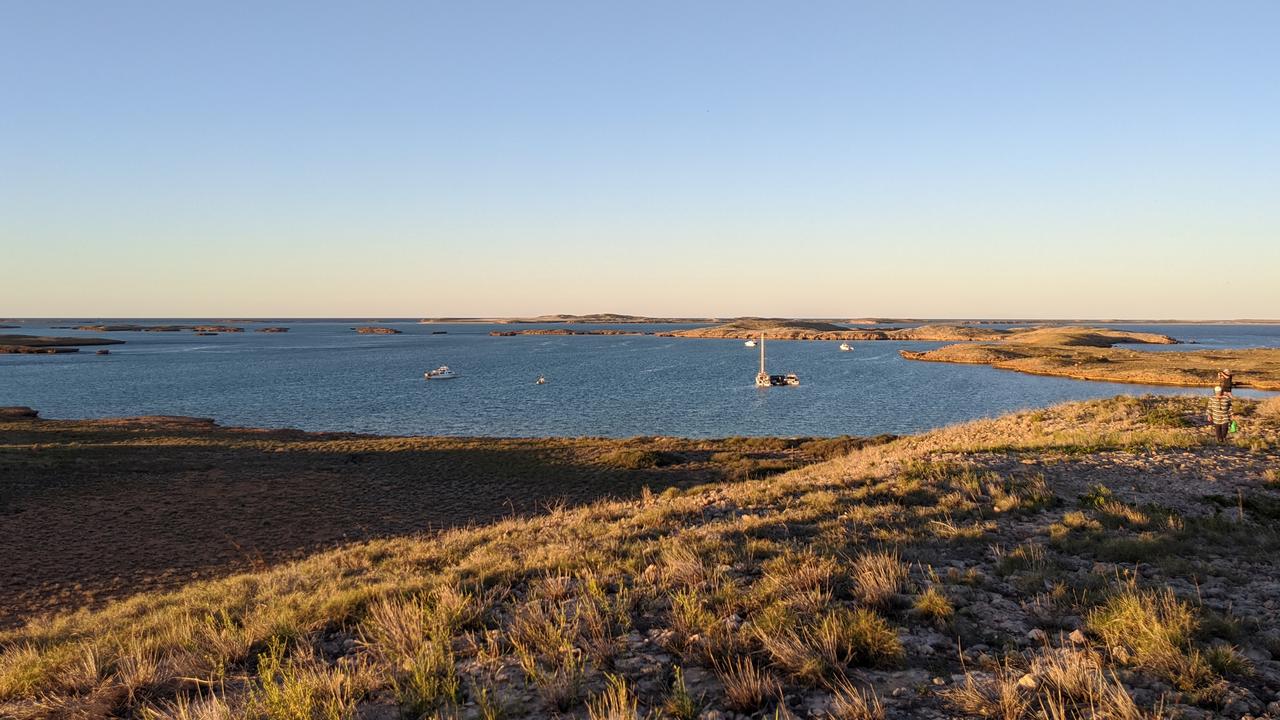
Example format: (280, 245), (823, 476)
(0, 396), (1280, 720)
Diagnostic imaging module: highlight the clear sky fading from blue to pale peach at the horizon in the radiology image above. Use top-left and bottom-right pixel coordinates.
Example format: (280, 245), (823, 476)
(0, 0), (1280, 319)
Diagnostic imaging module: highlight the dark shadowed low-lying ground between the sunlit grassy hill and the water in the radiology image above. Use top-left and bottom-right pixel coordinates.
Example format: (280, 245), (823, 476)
(0, 409), (861, 628)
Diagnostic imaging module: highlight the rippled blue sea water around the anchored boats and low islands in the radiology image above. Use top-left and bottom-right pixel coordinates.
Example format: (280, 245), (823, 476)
(0, 320), (1280, 437)
